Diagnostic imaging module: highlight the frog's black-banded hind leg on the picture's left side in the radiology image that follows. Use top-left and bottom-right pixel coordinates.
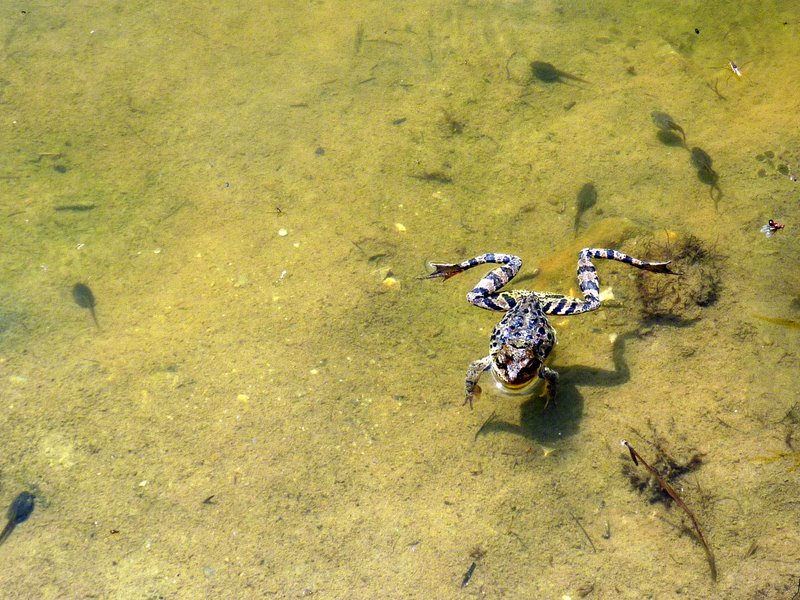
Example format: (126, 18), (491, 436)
(421, 252), (522, 312)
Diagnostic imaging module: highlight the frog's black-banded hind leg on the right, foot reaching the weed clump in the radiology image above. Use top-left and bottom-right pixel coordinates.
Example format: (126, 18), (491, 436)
(536, 248), (676, 315)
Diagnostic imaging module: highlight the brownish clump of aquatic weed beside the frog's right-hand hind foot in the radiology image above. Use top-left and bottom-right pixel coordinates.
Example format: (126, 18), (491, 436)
(636, 233), (722, 322)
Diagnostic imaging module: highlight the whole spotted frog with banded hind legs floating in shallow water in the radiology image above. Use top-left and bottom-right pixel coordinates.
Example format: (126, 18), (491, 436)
(423, 248), (674, 408)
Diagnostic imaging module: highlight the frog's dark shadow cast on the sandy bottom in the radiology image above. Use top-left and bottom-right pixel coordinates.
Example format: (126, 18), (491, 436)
(480, 331), (640, 444)
